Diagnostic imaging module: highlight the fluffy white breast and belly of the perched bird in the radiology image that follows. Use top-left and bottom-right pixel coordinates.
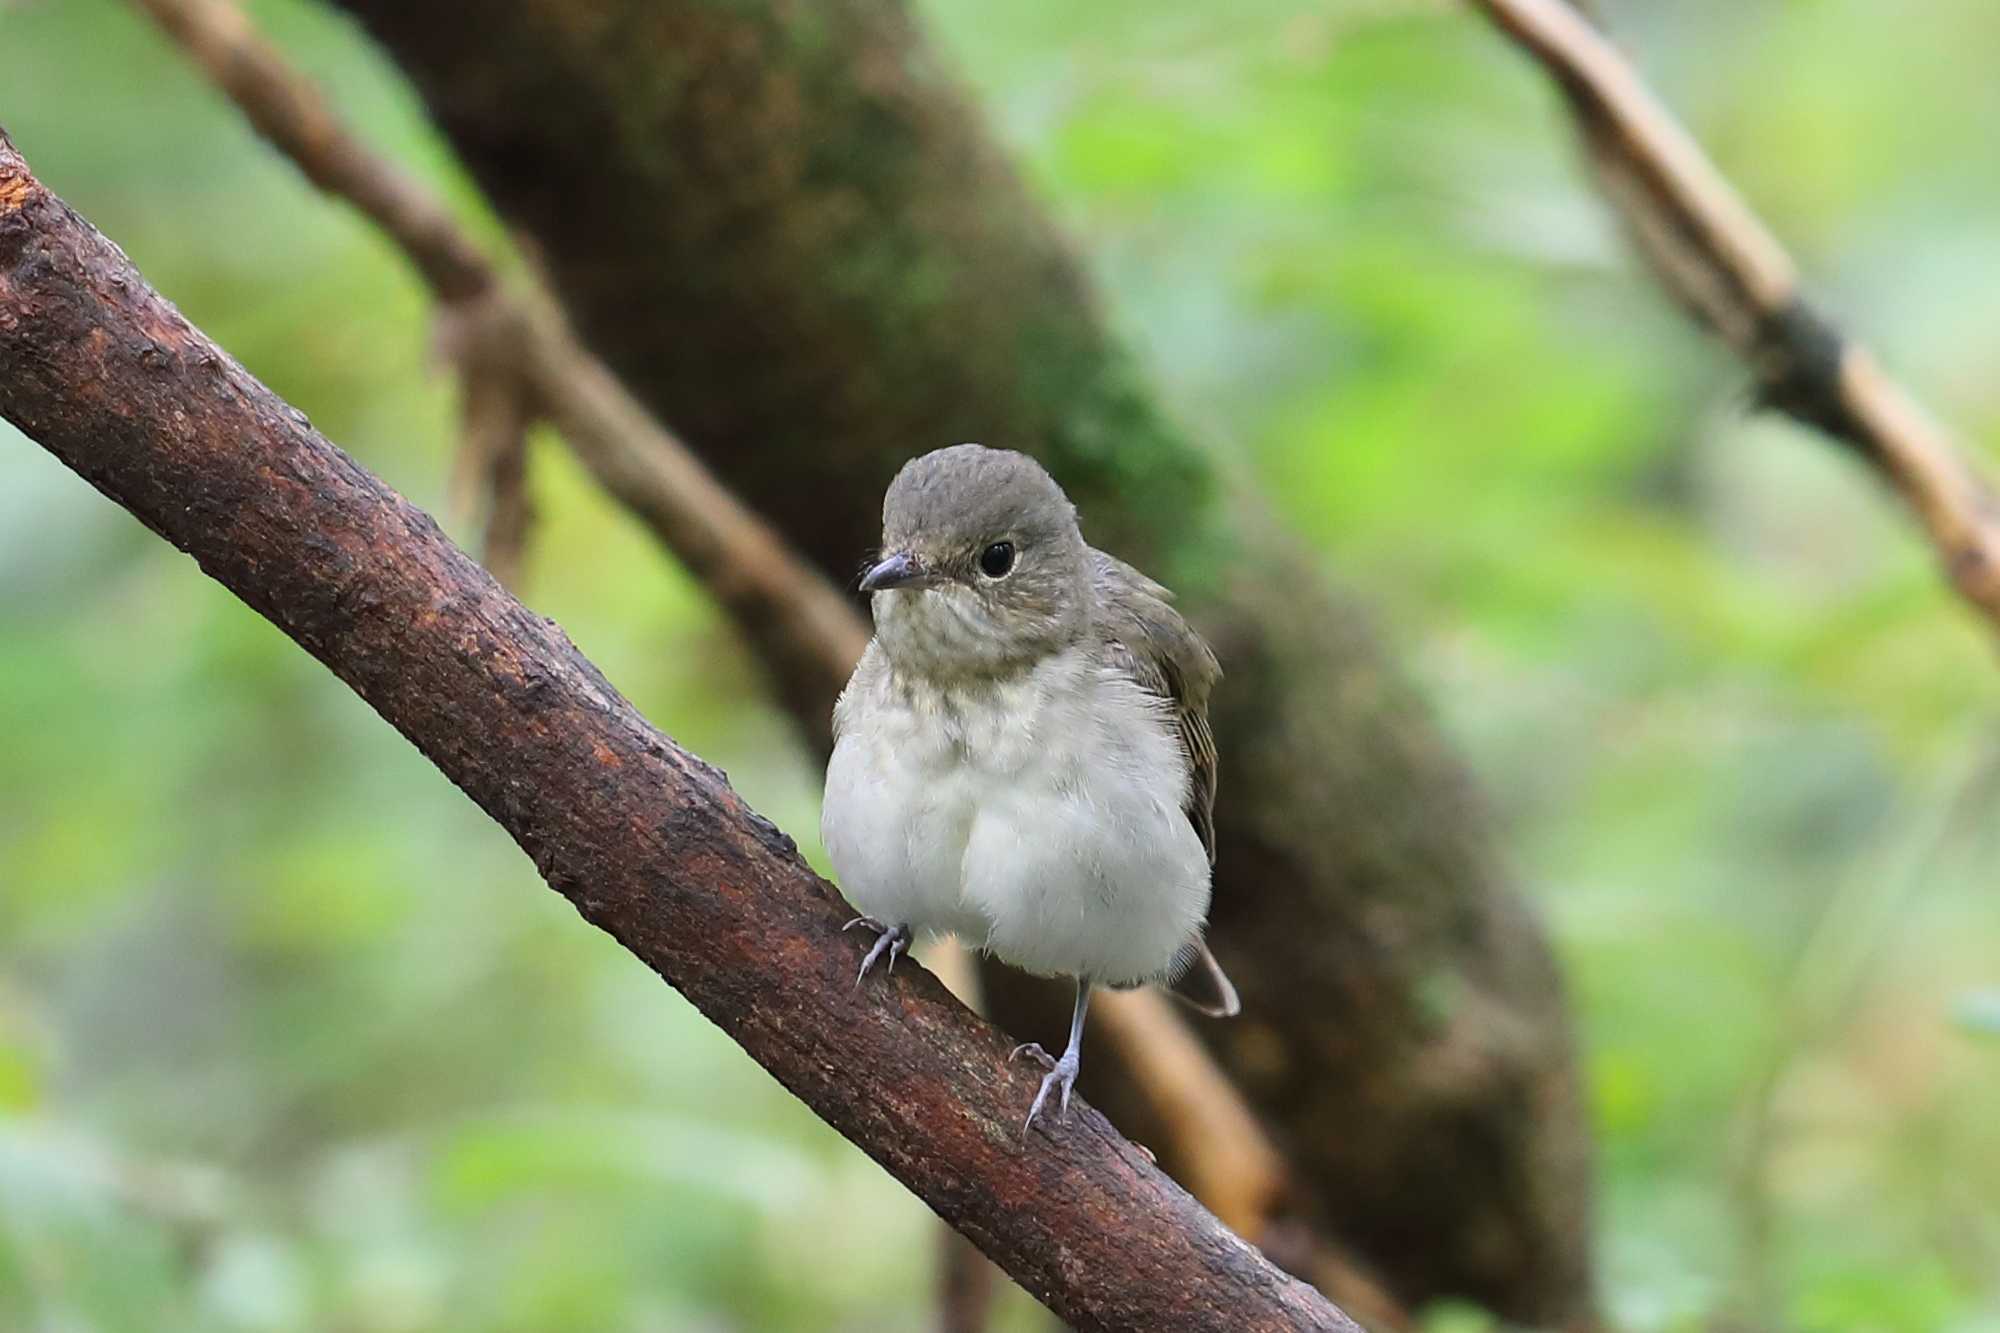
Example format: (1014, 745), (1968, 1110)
(822, 644), (1208, 983)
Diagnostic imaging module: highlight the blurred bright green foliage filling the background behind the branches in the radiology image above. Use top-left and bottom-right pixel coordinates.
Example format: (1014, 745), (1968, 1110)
(0, 0), (2000, 1333)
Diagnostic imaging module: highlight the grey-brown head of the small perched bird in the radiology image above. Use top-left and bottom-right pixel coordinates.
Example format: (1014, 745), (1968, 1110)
(860, 444), (1090, 681)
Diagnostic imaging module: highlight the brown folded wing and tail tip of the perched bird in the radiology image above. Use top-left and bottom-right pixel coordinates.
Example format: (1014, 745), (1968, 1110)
(1090, 550), (1242, 1017)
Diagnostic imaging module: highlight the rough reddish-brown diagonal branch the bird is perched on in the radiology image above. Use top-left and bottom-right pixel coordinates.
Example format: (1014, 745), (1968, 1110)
(0, 132), (1356, 1331)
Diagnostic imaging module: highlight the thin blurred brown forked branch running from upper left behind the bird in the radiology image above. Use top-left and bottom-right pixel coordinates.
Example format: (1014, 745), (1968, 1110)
(117, 0), (1408, 1304)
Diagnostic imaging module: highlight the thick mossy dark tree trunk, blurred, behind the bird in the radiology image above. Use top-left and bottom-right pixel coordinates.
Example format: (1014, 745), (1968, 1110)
(342, 0), (1592, 1325)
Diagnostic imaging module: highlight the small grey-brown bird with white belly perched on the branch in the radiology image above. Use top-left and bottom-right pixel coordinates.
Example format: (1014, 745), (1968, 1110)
(820, 444), (1240, 1135)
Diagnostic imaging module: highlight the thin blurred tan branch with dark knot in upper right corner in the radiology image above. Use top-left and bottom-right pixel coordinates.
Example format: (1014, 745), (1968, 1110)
(1472, 0), (2000, 630)
